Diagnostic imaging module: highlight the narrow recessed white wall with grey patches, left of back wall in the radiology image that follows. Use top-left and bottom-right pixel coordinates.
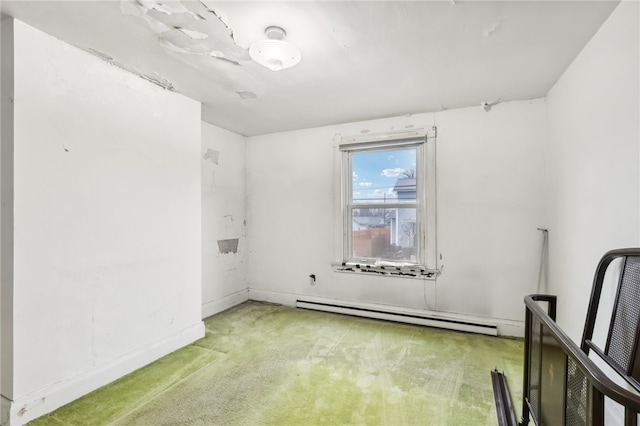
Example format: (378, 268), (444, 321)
(201, 122), (249, 318)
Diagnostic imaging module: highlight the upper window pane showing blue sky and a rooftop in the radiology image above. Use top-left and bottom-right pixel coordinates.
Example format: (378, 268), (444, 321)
(351, 148), (417, 204)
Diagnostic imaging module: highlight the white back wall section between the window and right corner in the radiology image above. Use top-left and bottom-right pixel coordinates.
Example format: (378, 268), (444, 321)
(437, 100), (544, 321)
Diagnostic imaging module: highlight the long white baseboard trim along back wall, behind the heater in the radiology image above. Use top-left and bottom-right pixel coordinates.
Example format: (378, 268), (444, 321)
(249, 288), (524, 337)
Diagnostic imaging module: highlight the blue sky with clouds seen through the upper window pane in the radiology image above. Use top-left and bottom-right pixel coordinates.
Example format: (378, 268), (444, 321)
(351, 148), (416, 202)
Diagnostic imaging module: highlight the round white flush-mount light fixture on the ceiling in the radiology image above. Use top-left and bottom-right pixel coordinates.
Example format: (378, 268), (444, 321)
(249, 27), (301, 71)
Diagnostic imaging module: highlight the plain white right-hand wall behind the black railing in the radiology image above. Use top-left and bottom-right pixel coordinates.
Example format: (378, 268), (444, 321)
(545, 1), (640, 340)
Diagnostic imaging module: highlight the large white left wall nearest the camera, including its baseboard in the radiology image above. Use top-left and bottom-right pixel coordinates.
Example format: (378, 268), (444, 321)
(3, 21), (204, 423)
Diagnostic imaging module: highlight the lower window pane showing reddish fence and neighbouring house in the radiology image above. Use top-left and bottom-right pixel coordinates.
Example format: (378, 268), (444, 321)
(351, 208), (417, 262)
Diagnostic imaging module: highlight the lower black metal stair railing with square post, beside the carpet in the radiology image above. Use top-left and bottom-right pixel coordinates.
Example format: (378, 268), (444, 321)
(516, 295), (640, 426)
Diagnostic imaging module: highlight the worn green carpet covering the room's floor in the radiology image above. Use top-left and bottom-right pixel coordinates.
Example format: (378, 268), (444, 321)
(30, 302), (523, 426)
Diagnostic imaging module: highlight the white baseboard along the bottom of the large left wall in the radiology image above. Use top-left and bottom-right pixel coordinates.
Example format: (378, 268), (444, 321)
(1, 321), (204, 426)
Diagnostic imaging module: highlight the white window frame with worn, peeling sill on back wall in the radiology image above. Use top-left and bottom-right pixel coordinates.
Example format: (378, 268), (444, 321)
(334, 127), (439, 278)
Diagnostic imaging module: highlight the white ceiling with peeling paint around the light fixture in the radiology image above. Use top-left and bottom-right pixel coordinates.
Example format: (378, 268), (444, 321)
(2, 0), (617, 136)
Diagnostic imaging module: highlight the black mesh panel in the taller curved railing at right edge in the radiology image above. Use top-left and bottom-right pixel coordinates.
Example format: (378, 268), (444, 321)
(607, 257), (640, 371)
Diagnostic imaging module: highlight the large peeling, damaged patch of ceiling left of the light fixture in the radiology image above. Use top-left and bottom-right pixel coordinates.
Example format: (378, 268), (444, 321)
(120, 0), (251, 64)
